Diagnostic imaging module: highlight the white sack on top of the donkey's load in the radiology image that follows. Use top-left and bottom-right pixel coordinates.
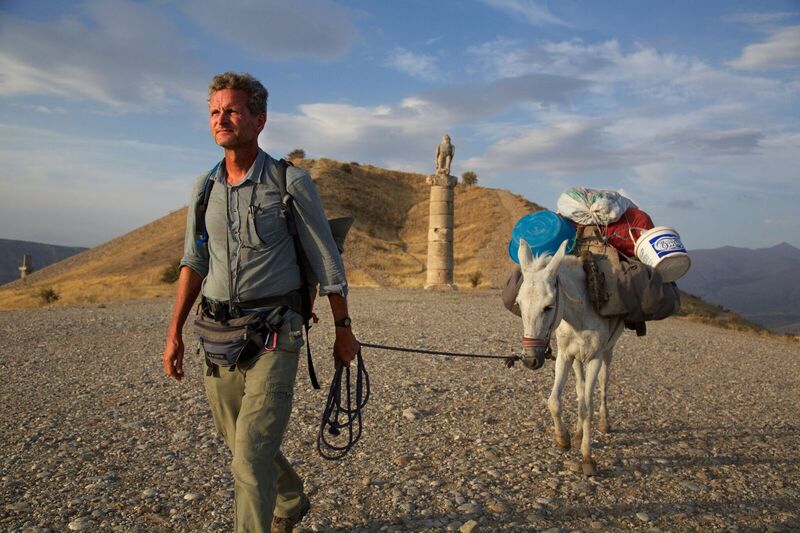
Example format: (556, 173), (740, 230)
(556, 187), (634, 226)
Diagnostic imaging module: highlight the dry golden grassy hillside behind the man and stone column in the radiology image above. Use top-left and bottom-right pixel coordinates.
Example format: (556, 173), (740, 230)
(0, 159), (540, 309)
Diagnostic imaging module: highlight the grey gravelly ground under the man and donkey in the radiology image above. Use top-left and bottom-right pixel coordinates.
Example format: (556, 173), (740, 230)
(0, 289), (800, 532)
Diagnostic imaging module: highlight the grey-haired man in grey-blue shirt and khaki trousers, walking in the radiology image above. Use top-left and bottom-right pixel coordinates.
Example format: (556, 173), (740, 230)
(164, 72), (359, 532)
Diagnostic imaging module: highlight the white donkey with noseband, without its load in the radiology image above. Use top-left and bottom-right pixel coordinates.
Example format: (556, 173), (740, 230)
(517, 240), (624, 476)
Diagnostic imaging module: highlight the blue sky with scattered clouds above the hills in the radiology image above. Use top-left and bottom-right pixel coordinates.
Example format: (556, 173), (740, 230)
(0, 0), (800, 249)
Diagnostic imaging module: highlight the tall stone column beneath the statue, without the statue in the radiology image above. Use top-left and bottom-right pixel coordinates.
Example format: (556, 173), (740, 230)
(425, 174), (458, 290)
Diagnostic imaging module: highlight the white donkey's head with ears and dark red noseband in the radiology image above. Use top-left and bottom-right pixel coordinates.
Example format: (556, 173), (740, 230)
(517, 239), (567, 369)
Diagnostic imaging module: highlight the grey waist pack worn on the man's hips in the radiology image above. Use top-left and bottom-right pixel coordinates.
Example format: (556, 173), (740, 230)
(194, 306), (289, 371)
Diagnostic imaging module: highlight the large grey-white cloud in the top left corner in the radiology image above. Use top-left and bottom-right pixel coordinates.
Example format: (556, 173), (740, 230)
(0, 0), (205, 110)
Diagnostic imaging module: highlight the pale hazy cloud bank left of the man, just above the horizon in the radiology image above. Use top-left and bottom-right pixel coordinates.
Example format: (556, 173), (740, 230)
(0, 124), (212, 246)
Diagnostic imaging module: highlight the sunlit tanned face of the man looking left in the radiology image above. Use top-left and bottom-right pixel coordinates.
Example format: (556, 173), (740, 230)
(208, 89), (267, 148)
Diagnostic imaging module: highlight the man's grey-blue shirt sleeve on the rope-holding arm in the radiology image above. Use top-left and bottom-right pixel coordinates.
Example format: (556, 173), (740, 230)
(286, 167), (348, 296)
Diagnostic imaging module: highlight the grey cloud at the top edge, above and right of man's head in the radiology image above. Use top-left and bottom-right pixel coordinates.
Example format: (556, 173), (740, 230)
(176, 0), (358, 60)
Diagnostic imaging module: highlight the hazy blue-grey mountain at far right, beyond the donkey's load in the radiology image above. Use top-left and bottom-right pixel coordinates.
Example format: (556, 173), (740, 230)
(678, 243), (800, 334)
